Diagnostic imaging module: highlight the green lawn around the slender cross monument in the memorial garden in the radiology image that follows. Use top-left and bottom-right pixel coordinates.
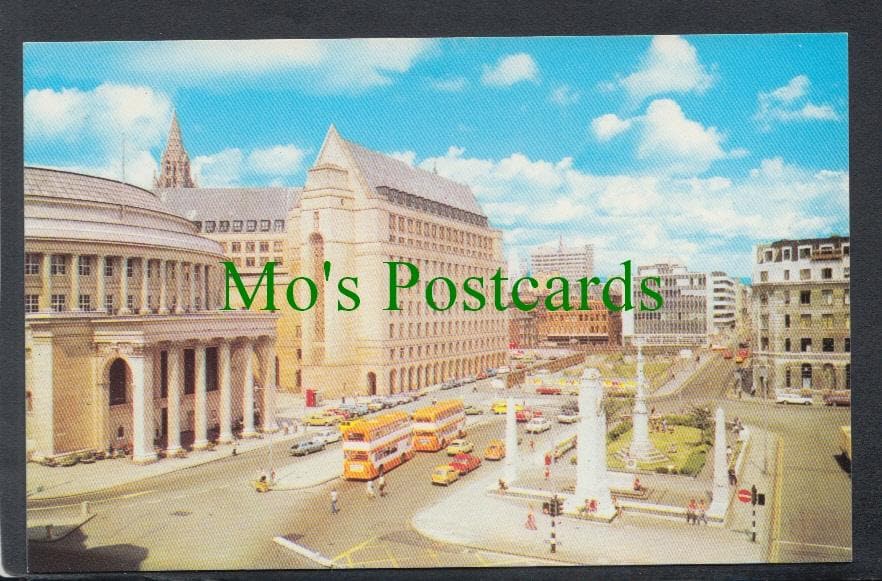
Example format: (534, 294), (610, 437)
(606, 426), (707, 474)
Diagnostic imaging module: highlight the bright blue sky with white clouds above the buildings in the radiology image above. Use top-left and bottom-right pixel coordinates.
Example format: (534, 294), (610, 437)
(24, 34), (849, 277)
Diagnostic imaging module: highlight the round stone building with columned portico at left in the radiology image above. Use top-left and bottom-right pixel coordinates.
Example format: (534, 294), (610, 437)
(24, 168), (277, 462)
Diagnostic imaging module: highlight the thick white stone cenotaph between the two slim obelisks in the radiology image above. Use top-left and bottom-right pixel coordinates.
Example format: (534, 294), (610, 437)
(567, 369), (615, 521)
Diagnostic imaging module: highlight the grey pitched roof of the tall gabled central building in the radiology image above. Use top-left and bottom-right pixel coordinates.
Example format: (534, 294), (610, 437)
(319, 125), (484, 216)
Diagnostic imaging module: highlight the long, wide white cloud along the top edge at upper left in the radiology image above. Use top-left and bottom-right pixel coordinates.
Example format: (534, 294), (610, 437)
(126, 38), (438, 92)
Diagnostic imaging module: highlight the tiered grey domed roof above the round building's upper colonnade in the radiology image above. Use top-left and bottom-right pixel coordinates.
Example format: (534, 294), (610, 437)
(24, 167), (223, 256)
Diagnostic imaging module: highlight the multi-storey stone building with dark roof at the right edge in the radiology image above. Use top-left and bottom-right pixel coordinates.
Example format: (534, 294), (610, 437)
(751, 236), (851, 397)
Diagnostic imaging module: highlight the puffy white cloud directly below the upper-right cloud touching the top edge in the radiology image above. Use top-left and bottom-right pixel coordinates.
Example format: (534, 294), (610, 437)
(637, 99), (726, 174)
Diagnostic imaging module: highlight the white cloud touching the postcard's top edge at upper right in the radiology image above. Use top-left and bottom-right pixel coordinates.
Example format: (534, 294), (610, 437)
(619, 36), (713, 101)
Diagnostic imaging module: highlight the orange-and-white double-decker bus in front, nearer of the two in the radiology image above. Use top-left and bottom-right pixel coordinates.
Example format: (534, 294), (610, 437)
(342, 412), (414, 480)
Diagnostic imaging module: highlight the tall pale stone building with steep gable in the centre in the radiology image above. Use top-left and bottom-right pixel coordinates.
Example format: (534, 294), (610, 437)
(288, 126), (508, 396)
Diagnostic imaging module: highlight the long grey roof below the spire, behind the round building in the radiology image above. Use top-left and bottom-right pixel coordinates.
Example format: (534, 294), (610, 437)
(157, 187), (301, 221)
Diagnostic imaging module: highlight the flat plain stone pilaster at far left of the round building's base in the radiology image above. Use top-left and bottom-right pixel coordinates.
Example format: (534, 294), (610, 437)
(29, 334), (55, 456)
